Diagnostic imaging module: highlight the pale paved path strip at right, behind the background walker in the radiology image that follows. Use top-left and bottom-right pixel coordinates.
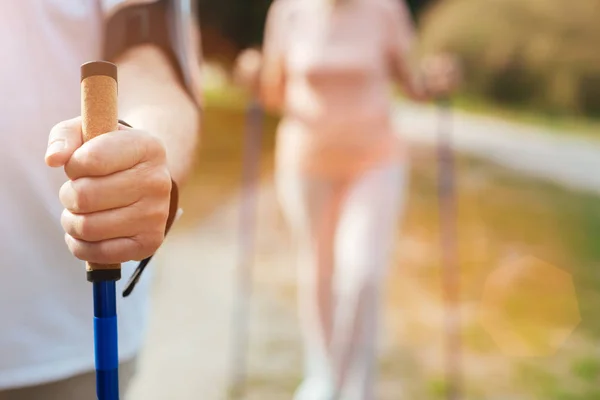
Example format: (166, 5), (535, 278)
(395, 103), (600, 193)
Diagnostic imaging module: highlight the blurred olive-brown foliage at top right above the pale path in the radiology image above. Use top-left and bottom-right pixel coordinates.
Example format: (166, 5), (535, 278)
(421, 0), (600, 116)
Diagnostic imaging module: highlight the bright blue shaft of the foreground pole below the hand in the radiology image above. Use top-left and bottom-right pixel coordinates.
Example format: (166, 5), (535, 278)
(93, 281), (119, 400)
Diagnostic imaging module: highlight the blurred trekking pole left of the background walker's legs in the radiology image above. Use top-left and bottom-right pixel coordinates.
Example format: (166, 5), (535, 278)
(230, 99), (263, 398)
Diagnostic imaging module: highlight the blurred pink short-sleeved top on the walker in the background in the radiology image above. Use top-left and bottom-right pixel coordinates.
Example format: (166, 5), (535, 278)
(265, 0), (414, 175)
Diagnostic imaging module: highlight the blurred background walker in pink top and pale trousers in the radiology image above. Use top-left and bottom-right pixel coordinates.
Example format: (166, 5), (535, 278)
(235, 0), (458, 400)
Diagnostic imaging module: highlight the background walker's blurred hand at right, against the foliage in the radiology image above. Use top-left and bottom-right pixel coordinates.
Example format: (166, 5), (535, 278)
(422, 54), (462, 97)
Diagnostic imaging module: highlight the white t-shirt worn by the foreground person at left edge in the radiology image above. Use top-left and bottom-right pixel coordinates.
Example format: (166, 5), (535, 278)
(0, 0), (202, 390)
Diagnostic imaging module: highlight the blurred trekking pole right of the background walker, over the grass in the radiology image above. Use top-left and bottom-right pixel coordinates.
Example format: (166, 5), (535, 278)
(438, 99), (462, 400)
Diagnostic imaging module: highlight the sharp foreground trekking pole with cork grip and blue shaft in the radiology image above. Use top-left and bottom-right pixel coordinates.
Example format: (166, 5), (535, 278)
(81, 61), (121, 400)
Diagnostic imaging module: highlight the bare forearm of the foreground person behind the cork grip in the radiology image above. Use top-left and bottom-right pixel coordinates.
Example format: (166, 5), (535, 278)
(117, 46), (200, 186)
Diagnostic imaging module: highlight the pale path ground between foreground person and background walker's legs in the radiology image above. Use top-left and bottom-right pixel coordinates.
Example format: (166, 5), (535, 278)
(123, 188), (310, 400)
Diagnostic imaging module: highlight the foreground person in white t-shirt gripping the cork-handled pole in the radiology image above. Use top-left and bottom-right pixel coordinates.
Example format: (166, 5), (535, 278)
(0, 0), (200, 400)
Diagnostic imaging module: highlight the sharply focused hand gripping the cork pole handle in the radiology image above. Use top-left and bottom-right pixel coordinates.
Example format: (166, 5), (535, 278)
(46, 118), (171, 264)
